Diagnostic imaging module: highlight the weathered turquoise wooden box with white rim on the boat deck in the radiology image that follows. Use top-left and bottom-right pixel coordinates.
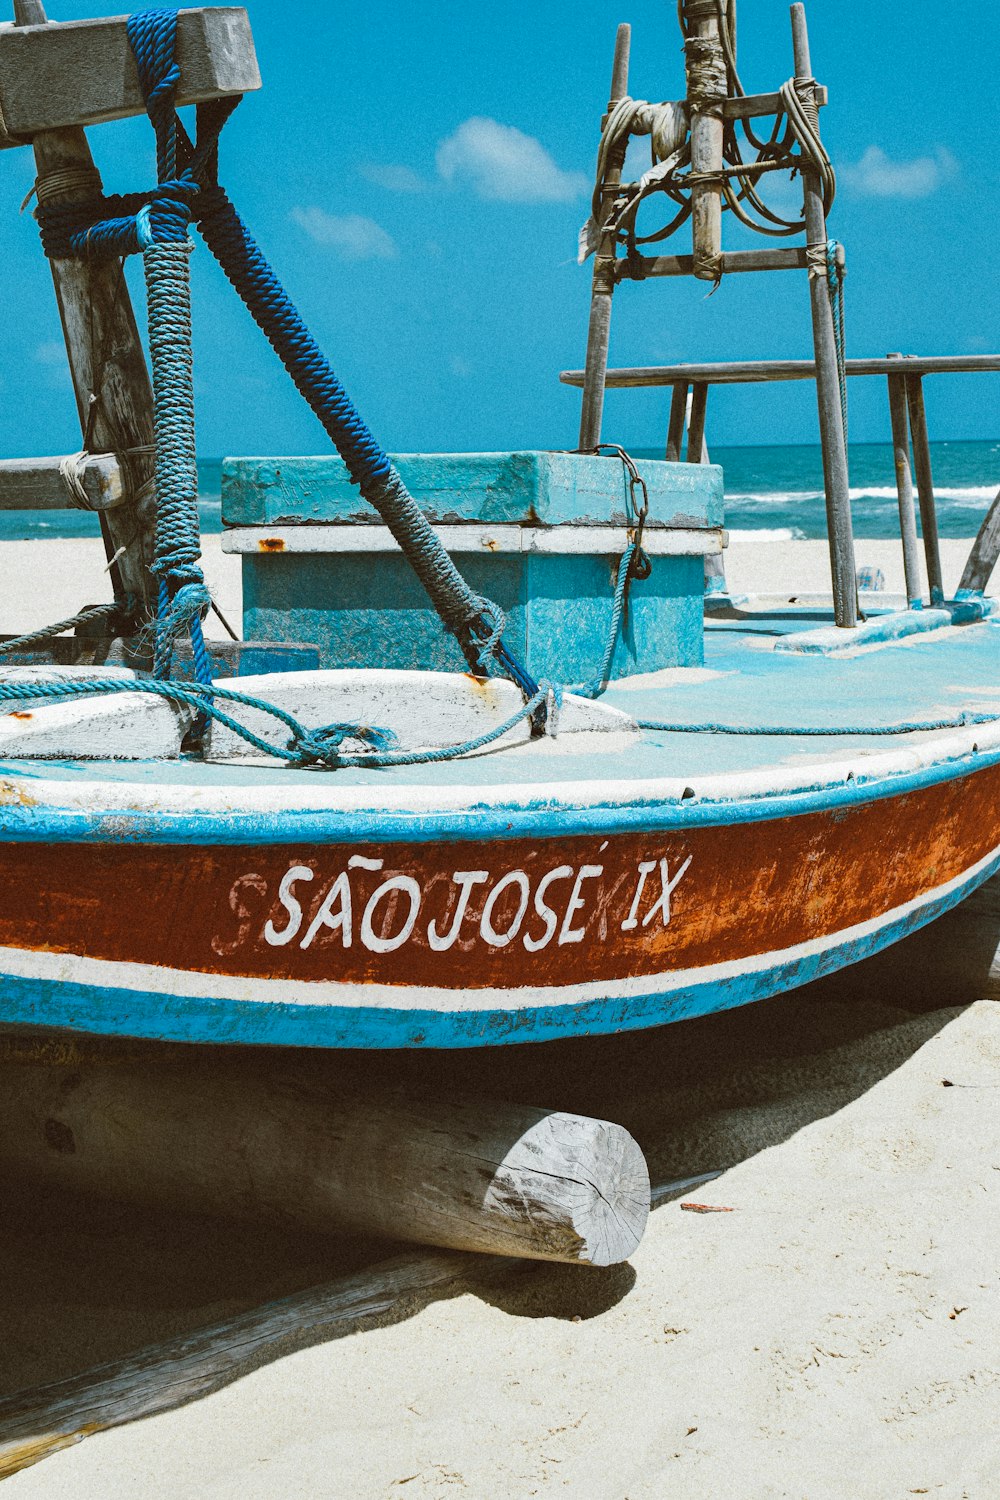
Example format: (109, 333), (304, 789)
(222, 452), (724, 683)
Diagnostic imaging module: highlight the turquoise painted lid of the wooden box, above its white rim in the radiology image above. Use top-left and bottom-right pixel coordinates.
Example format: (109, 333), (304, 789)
(222, 452), (723, 527)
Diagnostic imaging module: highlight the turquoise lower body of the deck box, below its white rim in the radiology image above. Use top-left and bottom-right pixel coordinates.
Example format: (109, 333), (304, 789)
(243, 552), (703, 683)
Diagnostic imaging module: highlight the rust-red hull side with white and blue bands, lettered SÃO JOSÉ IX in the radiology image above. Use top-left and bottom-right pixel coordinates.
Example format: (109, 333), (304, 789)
(0, 758), (1000, 1047)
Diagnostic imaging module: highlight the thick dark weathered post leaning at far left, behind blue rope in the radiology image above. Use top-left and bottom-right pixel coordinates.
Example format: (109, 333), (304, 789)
(15, 0), (156, 612)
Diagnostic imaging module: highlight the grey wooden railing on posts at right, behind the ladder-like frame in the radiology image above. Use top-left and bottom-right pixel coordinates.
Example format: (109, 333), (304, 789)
(559, 354), (1000, 608)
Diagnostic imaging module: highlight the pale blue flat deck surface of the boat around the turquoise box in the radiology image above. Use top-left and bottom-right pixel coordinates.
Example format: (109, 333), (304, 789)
(0, 608), (1000, 806)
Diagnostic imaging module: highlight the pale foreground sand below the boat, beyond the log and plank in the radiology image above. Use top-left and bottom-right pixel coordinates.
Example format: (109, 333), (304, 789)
(9, 996), (1000, 1500)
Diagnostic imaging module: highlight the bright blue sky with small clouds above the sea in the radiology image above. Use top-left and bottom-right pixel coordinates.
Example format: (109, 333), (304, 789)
(0, 0), (1000, 455)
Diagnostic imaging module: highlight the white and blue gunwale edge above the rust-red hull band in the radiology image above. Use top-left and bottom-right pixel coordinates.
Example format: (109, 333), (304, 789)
(0, 722), (1000, 845)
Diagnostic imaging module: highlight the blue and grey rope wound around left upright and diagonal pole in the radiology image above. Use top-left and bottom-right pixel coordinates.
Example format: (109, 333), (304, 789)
(36, 9), (537, 698)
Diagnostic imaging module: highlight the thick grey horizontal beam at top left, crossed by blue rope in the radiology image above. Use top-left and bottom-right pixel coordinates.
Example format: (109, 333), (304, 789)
(0, 6), (261, 144)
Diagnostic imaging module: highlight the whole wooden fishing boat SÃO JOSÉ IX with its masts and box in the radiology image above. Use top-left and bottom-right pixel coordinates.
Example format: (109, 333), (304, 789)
(0, 0), (1000, 1049)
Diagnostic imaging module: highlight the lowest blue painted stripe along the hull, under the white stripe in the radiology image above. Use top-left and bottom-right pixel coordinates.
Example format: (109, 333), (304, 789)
(4, 857), (1000, 1050)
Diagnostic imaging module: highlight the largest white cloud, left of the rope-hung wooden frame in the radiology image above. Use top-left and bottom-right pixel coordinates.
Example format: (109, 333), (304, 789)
(436, 116), (588, 203)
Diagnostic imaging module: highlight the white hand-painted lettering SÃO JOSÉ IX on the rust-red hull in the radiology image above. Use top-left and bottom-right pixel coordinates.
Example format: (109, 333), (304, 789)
(235, 855), (691, 953)
